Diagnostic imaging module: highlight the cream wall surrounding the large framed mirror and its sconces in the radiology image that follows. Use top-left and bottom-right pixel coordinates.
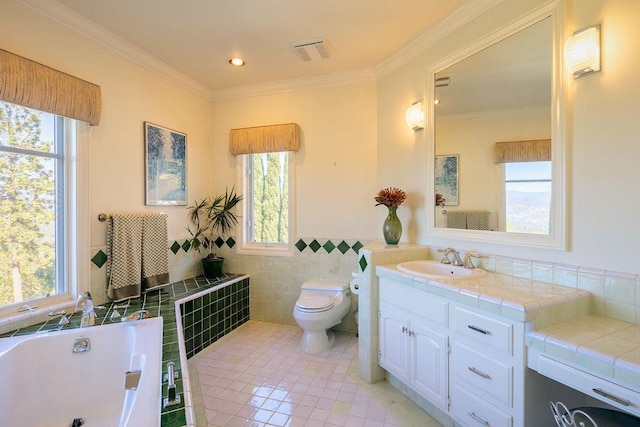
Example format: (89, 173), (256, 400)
(378, 0), (640, 273)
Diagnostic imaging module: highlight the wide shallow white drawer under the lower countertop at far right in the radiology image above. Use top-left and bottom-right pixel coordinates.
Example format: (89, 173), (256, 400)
(538, 356), (640, 416)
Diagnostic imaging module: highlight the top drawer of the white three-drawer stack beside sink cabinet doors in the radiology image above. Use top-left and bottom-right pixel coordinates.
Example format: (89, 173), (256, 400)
(454, 308), (513, 354)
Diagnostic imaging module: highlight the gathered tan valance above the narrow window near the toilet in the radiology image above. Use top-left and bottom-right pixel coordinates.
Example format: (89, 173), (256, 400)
(229, 123), (300, 156)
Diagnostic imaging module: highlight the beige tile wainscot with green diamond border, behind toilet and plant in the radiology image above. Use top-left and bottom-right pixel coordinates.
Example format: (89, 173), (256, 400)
(92, 236), (366, 334)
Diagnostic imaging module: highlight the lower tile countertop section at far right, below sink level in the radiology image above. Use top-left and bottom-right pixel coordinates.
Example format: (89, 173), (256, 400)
(525, 314), (640, 390)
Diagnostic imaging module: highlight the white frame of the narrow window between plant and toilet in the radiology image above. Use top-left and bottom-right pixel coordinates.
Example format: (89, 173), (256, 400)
(236, 151), (296, 257)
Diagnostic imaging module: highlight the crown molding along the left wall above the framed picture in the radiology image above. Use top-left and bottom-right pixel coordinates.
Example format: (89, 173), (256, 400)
(16, 0), (211, 100)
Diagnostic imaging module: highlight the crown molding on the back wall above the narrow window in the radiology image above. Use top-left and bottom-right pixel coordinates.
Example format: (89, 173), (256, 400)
(212, 68), (376, 101)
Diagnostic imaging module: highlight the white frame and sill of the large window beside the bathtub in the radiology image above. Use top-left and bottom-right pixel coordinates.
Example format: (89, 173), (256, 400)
(0, 105), (91, 322)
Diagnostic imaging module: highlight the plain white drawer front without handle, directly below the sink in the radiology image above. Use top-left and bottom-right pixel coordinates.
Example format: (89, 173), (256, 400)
(380, 279), (449, 326)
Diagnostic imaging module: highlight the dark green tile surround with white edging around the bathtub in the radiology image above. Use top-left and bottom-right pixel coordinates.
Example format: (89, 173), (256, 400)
(0, 275), (249, 427)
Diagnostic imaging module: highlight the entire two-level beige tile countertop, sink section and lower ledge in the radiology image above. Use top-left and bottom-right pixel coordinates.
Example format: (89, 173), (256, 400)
(376, 265), (640, 402)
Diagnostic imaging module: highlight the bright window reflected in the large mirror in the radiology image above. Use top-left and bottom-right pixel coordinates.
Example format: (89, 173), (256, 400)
(503, 161), (551, 234)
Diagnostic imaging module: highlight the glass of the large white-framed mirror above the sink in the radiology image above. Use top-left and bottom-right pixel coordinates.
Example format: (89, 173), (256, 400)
(434, 18), (553, 235)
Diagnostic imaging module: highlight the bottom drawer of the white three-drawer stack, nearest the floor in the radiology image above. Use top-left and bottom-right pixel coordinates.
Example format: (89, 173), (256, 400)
(451, 384), (513, 427)
